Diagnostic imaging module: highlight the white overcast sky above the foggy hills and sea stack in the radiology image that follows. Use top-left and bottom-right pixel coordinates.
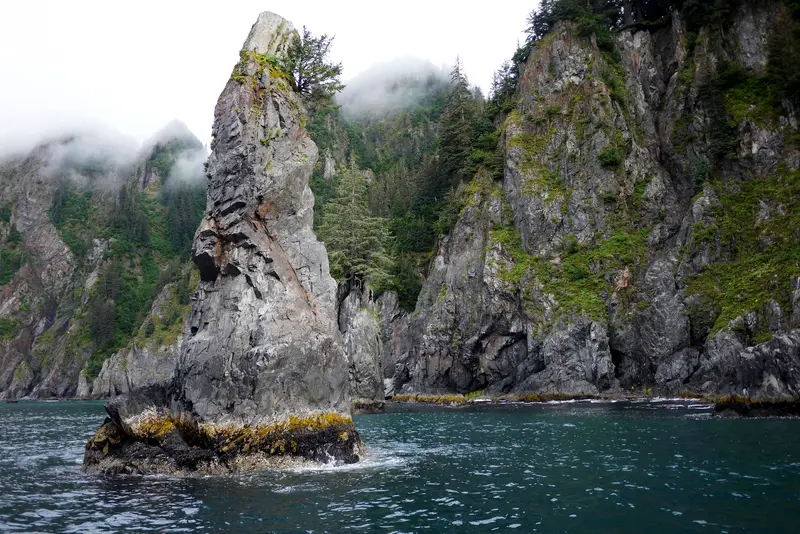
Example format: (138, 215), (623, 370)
(0, 0), (538, 150)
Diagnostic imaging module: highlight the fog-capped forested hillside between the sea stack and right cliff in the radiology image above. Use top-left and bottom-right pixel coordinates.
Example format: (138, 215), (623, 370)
(309, 58), (501, 310)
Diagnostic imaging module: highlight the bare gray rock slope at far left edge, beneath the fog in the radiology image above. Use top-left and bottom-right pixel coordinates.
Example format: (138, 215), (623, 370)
(0, 146), (78, 398)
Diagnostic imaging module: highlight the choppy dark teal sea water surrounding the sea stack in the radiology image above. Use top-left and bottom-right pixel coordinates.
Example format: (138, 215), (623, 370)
(0, 402), (800, 533)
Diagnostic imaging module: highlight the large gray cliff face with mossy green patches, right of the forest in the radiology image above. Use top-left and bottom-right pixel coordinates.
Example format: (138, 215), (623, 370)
(381, 2), (800, 397)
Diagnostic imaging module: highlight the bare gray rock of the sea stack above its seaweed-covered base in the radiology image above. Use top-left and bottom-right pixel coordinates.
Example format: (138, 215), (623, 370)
(176, 14), (349, 425)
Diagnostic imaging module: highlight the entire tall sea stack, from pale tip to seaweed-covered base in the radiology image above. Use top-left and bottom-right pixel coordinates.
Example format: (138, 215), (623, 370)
(84, 12), (361, 474)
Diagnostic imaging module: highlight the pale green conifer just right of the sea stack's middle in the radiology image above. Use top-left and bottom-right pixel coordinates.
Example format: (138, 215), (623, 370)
(318, 165), (392, 290)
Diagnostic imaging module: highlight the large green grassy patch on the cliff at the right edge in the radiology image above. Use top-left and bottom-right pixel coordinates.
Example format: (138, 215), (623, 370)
(688, 171), (800, 335)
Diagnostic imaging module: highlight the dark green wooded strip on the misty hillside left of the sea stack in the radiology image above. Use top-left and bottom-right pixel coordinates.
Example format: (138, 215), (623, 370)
(44, 138), (205, 379)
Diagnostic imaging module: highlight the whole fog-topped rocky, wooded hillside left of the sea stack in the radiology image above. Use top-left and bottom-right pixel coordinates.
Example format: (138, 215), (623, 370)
(0, 123), (205, 396)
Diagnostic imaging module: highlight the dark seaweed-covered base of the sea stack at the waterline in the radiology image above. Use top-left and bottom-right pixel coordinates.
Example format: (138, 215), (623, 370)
(83, 413), (362, 475)
